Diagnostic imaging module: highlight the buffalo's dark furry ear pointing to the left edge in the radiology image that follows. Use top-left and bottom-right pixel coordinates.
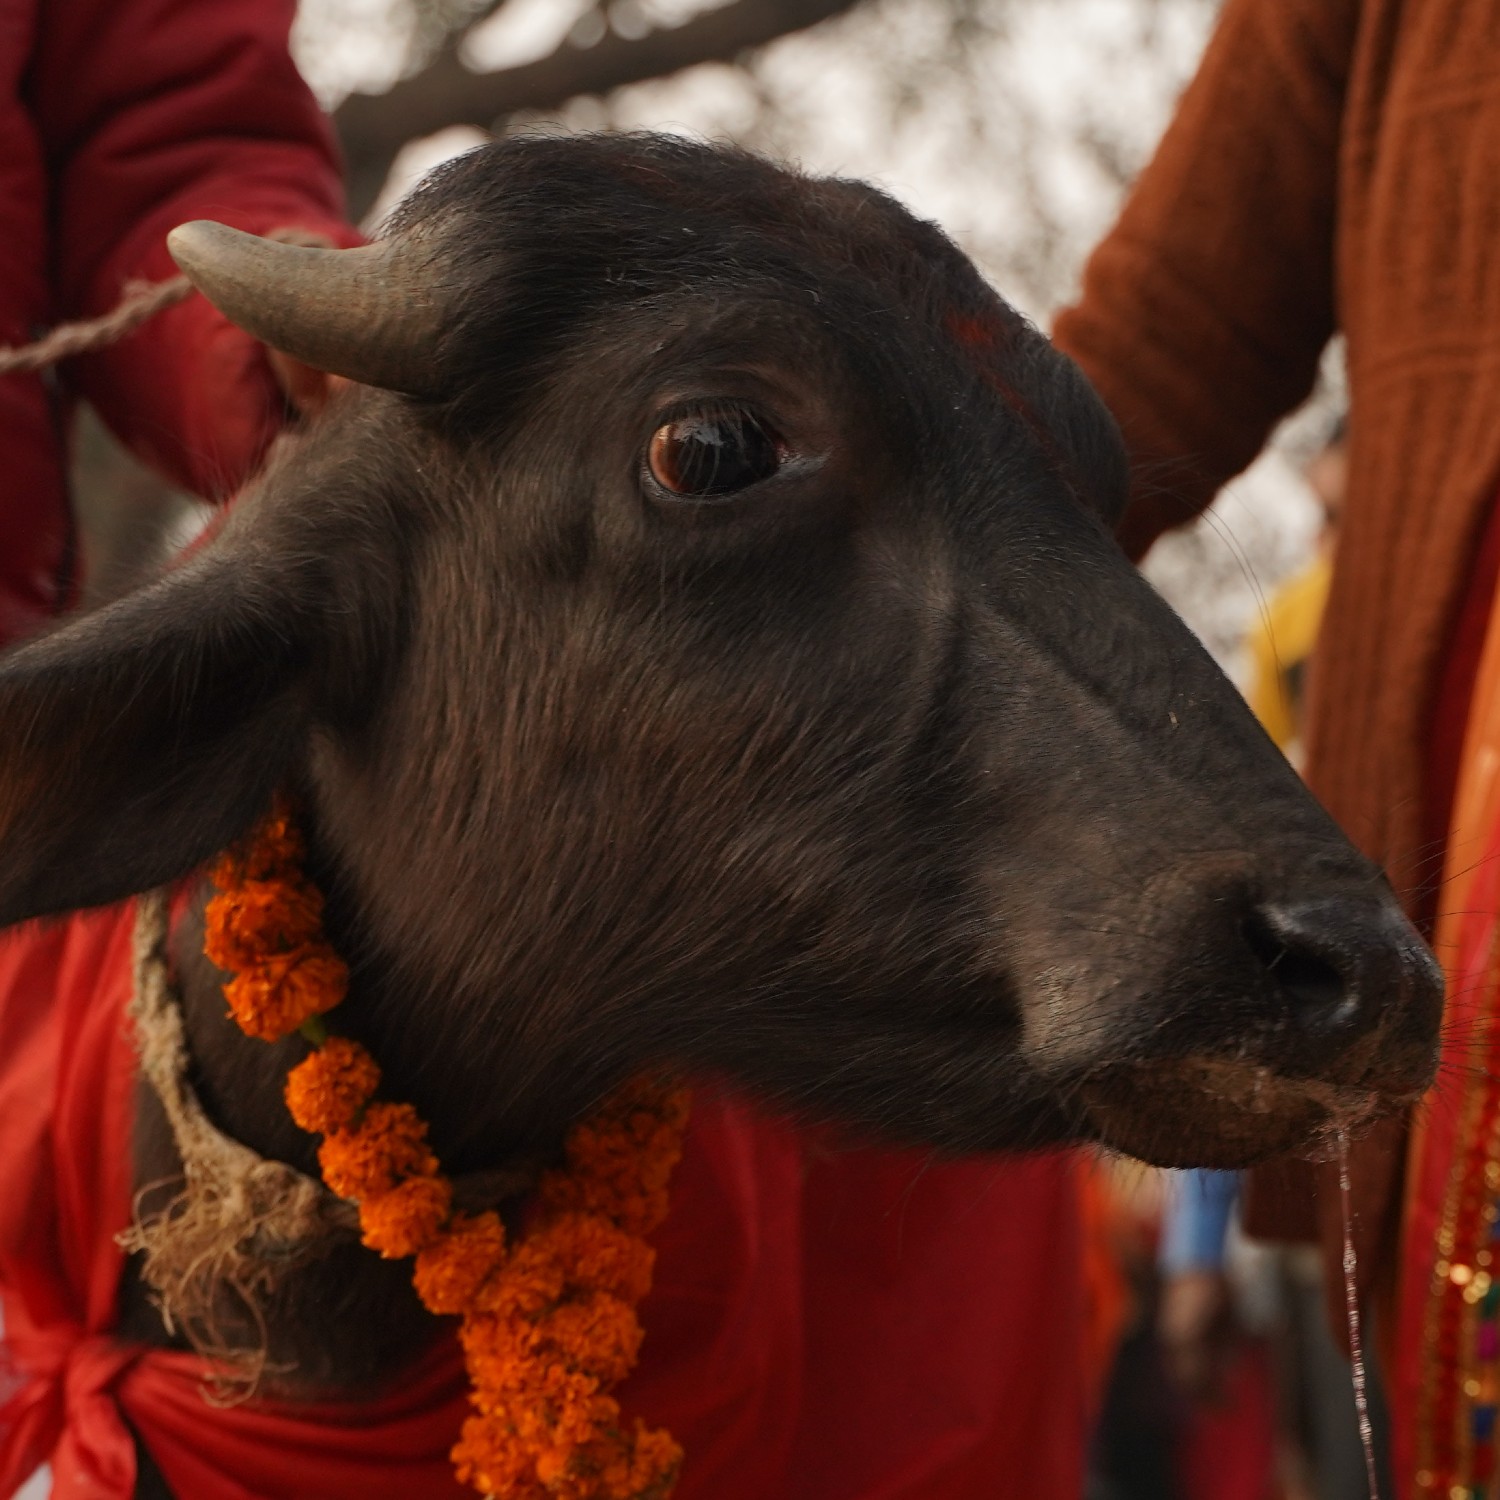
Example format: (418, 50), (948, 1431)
(0, 548), (312, 924)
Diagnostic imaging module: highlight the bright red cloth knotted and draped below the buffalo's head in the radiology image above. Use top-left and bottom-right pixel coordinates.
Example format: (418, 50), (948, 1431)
(0, 906), (1089, 1500)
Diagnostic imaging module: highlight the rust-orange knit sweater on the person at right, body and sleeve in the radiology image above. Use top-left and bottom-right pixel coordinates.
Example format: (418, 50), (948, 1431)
(1056, 0), (1500, 893)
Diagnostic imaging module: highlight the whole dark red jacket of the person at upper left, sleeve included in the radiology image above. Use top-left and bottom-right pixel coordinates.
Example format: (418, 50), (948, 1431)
(0, 0), (348, 644)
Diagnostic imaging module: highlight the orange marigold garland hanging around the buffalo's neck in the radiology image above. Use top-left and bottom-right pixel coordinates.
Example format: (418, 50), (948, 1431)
(204, 801), (687, 1500)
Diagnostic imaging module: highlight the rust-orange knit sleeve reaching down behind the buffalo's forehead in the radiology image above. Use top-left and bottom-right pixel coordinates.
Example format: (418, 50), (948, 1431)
(1055, 0), (1359, 557)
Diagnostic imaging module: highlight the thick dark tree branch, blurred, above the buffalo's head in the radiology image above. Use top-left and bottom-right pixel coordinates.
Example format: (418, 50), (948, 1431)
(335, 0), (858, 216)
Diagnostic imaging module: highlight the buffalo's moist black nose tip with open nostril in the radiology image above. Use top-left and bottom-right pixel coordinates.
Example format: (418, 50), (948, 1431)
(1244, 896), (1443, 1073)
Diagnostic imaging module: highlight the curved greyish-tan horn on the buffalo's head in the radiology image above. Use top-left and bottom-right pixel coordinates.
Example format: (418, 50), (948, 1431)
(167, 219), (440, 396)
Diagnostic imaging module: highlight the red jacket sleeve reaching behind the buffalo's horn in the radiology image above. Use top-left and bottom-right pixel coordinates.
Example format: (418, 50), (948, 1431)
(30, 0), (357, 497)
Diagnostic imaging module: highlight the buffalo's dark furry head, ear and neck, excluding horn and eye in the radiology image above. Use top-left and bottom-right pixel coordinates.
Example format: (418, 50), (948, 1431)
(0, 138), (1437, 1452)
